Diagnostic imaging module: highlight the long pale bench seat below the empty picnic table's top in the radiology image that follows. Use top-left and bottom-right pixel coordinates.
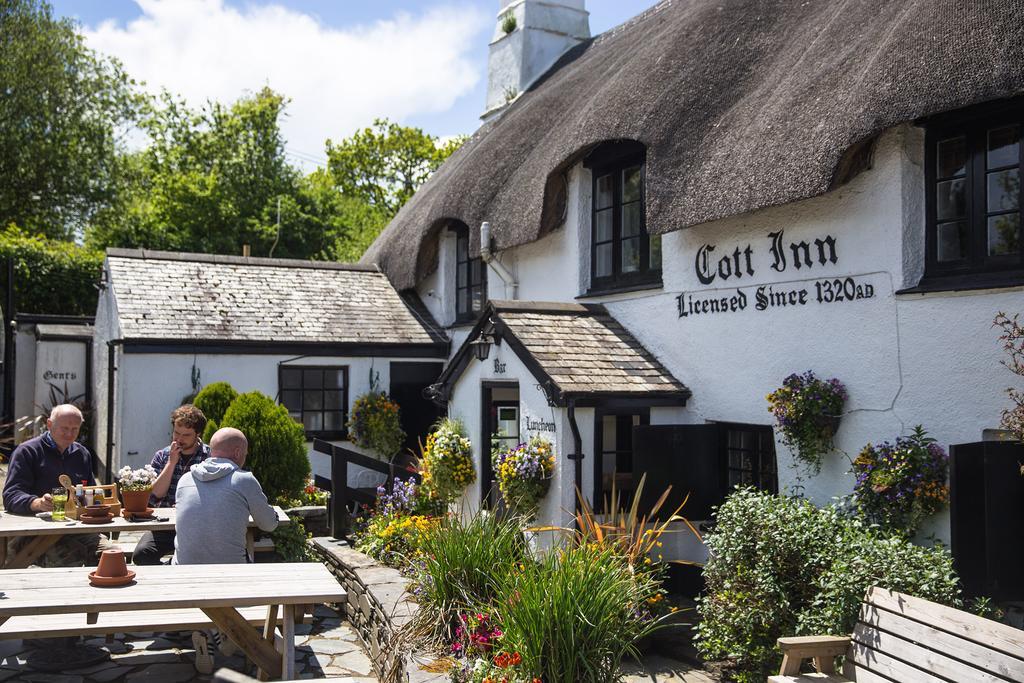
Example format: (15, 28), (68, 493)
(0, 610), (312, 640)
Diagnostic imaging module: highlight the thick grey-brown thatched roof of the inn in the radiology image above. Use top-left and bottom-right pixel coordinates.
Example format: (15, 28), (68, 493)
(362, 0), (1024, 289)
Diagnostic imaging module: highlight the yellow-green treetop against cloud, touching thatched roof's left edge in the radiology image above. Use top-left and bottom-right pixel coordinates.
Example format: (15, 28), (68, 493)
(327, 119), (466, 219)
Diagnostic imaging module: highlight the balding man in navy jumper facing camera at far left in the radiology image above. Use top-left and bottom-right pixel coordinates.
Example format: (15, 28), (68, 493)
(3, 403), (99, 566)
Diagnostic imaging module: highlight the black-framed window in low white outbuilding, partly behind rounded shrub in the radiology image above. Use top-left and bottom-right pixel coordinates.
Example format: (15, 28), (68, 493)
(278, 366), (348, 438)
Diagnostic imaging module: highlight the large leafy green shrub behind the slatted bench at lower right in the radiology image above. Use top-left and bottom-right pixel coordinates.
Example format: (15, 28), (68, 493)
(696, 488), (959, 681)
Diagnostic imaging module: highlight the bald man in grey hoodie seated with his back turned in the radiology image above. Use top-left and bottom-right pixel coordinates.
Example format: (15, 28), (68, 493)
(173, 427), (278, 564)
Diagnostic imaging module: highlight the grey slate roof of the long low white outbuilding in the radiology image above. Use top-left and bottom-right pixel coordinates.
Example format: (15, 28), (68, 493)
(106, 249), (447, 356)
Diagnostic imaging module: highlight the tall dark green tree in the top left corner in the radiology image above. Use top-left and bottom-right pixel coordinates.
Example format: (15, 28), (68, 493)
(0, 0), (143, 240)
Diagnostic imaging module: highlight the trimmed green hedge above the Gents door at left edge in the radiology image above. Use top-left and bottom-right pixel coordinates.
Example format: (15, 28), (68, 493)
(0, 226), (103, 315)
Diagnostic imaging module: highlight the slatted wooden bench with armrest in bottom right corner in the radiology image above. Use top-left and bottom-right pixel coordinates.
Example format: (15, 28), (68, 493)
(768, 588), (1024, 683)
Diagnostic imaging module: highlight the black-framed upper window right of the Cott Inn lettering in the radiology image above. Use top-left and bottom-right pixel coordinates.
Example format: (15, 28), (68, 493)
(923, 99), (1024, 288)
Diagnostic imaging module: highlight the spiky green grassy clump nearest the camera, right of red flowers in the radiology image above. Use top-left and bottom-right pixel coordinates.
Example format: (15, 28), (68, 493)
(497, 544), (659, 683)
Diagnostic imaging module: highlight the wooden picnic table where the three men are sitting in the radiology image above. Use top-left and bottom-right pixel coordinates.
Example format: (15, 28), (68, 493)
(0, 506), (291, 579)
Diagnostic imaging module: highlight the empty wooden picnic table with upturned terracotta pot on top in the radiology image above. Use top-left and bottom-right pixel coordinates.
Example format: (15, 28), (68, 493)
(0, 562), (345, 680)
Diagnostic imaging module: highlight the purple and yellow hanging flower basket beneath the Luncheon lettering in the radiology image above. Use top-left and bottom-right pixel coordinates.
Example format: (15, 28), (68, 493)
(493, 436), (555, 517)
